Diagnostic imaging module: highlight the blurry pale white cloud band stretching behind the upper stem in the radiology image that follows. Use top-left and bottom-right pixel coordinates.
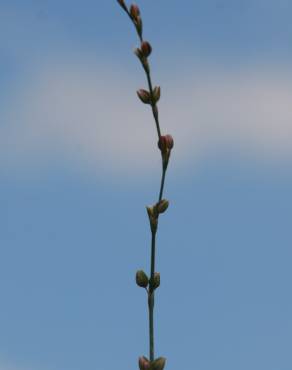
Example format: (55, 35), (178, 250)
(0, 62), (292, 173)
